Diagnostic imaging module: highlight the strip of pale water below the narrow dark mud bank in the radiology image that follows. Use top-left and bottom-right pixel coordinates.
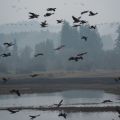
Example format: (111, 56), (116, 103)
(0, 110), (120, 120)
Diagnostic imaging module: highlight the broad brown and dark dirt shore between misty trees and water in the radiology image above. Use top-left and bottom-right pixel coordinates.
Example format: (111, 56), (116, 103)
(0, 71), (120, 94)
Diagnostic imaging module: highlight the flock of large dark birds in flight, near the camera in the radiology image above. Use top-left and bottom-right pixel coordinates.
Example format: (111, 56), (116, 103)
(0, 5), (120, 120)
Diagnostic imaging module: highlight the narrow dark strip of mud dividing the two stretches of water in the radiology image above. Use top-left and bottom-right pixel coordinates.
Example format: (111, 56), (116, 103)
(0, 106), (120, 113)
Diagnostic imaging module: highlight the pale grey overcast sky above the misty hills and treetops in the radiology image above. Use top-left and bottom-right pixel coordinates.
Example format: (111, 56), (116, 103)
(0, 0), (120, 24)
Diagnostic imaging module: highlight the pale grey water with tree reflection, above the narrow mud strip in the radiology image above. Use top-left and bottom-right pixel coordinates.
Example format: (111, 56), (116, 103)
(0, 90), (120, 107)
